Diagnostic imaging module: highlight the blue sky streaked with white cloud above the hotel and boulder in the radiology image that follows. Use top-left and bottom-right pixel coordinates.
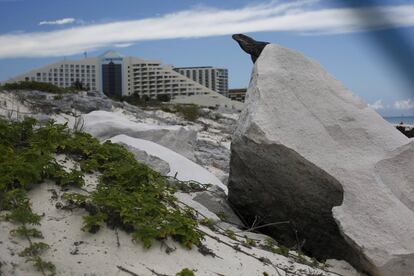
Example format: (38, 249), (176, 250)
(0, 0), (414, 116)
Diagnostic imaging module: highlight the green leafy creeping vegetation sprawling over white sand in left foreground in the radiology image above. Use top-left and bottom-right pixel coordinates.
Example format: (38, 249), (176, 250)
(0, 119), (202, 275)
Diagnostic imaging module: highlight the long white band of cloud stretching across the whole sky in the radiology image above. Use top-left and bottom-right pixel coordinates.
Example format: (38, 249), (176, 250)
(0, 0), (414, 58)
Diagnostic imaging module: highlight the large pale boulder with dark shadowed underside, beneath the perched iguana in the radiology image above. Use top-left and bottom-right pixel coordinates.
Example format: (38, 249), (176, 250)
(228, 44), (414, 275)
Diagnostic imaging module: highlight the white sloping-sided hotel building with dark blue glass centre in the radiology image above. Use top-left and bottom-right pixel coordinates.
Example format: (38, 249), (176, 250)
(7, 51), (233, 100)
